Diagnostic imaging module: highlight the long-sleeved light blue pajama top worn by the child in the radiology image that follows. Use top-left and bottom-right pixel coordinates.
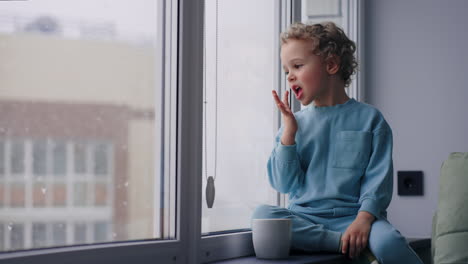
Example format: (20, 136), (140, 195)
(267, 99), (393, 218)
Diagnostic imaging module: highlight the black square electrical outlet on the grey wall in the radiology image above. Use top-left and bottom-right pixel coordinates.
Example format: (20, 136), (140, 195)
(398, 171), (423, 196)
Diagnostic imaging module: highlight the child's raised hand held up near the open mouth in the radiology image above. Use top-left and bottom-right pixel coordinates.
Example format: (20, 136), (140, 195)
(272, 90), (297, 145)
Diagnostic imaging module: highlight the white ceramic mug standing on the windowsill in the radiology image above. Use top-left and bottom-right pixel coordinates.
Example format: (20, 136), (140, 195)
(252, 219), (292, 259)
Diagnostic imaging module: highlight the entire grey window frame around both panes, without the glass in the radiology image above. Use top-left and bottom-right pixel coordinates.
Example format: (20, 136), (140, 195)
(0, 0), (363, 264)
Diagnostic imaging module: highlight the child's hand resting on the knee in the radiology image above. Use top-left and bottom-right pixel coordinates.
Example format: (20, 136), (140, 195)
(341, 211), (375, 258)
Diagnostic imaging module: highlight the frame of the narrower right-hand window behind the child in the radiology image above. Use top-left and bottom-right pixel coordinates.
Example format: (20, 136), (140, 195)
(196, 0), (364, 263)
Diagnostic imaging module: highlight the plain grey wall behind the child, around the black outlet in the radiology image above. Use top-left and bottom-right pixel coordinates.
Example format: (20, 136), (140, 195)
(363, 0), (468, 237)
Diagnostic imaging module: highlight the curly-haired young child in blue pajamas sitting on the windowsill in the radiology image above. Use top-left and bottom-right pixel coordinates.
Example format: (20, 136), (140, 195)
(253, 23), (422, 264)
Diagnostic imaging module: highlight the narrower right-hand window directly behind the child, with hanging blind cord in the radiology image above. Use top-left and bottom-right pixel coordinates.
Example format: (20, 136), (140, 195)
(202, 0), (358, 261)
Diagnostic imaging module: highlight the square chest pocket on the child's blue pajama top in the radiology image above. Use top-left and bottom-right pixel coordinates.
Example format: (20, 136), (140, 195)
(333, 131), (372, 169)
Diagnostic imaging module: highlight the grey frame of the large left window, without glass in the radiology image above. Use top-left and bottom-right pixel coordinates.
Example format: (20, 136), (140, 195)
(0, 0), (200, 264)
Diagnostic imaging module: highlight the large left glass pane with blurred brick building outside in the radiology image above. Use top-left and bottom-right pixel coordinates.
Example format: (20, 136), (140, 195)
(0, 0), (173, 251)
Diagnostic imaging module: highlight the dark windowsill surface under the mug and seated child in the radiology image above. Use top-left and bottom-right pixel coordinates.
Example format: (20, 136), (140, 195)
(211, 238), (431, 264)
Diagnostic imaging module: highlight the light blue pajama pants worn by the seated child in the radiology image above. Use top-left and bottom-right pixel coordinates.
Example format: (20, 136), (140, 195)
(252, 205), (423, 264)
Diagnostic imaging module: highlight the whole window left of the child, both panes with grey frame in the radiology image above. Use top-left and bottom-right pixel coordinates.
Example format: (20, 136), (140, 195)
(0, 0), (362, 264)
